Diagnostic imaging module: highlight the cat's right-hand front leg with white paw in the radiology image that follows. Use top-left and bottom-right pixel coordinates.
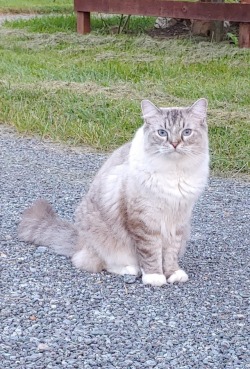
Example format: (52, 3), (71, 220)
(163, 226), (189, 283)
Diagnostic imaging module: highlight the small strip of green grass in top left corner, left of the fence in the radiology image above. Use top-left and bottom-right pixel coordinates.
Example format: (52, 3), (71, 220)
(0, 0), (73, 13)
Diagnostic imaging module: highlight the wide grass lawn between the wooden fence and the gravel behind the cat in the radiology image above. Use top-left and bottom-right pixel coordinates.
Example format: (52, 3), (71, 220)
(0, 14), (250, 175)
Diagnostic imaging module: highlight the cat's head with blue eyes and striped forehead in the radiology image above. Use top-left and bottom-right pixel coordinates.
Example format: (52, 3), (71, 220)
(141, 98), (208, 157)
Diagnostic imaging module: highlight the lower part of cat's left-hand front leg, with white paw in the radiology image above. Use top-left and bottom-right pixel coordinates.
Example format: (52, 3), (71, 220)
(137, 240), (167, 286)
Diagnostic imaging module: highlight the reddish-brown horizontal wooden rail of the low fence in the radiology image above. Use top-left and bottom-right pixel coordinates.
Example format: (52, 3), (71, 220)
(74, 0), (250, 22)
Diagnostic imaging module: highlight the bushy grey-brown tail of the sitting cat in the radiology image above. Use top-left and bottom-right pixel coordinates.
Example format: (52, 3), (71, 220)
(18, 200), (78, 256)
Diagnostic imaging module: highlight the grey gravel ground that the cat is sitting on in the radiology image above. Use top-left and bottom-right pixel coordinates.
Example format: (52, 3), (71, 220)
(0, 129), (250, 369)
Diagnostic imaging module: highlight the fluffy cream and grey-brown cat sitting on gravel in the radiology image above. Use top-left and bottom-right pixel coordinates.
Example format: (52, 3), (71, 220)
(19, 98), (209, 286)
